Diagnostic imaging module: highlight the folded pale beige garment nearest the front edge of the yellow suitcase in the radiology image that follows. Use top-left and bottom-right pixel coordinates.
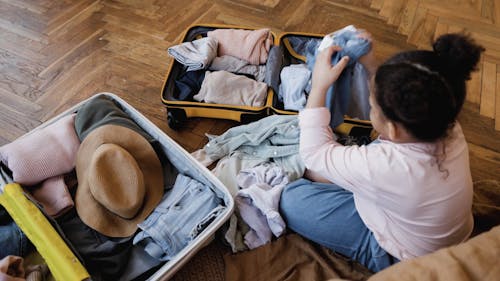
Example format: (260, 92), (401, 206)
(193, 71), (267, 106)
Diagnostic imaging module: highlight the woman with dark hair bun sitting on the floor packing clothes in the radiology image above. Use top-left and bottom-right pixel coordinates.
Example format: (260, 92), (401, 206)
(280, 34), (484, 271)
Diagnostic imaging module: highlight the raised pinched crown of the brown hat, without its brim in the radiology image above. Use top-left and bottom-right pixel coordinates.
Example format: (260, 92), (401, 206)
(88, 143), (146, 219)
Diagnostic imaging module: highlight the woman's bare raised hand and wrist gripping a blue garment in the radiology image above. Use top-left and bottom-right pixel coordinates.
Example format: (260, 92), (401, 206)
(306, 46), (349, 108)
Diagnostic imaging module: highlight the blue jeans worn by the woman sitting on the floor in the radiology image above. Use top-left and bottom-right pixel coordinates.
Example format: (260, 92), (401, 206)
(280, 179), (397, 272)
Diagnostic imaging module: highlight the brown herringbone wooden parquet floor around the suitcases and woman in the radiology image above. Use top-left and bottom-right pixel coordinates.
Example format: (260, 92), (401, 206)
(0, 0), (500, 278)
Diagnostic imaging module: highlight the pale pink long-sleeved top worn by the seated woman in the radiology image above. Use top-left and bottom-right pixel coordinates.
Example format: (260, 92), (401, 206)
(299, 107), (474, 259)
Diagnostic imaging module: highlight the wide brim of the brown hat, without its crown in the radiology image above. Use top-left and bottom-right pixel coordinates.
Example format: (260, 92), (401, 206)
(75, 125), (164, 237)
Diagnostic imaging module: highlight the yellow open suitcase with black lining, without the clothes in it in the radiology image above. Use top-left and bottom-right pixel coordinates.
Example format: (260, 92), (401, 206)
(161, 24), (377, 140)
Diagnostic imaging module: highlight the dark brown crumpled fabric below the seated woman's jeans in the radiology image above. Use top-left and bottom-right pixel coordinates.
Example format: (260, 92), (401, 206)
(224, 234), (371, 281)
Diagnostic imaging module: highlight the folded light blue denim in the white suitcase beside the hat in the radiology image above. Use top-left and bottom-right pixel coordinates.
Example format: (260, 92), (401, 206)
(133, 174), (225, 261)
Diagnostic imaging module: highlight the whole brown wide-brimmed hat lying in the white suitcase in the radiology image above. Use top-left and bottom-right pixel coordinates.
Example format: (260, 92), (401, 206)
(75, 125), (163, 237)
